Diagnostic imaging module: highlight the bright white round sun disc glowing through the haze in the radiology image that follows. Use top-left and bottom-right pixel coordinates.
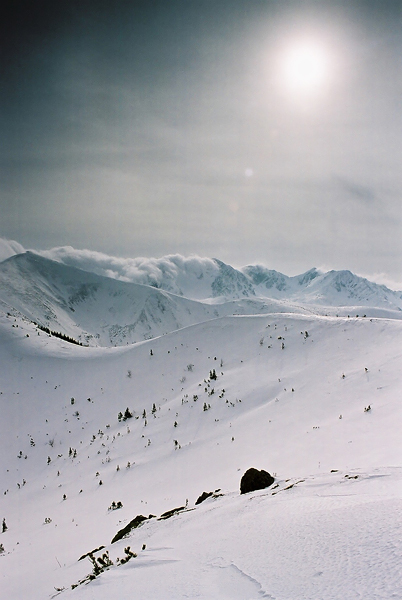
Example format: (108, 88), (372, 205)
(282, 41), (330, 94)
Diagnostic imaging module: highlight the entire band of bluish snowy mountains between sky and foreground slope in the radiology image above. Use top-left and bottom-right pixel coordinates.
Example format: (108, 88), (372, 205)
(0, 252), (402, 346)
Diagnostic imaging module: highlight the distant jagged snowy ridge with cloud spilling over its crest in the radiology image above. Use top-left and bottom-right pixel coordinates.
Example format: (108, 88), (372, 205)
(18, 247), (402, 310)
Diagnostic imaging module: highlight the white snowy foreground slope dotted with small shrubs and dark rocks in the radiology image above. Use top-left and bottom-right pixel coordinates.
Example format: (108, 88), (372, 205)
(0, 255), (402, 600)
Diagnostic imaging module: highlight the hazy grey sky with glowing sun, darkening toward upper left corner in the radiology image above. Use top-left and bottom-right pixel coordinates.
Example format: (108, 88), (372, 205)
(0, 0), (402, 281)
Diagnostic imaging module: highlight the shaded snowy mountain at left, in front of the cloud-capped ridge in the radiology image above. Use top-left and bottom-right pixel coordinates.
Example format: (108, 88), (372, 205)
(0, 252), (310, 346)
